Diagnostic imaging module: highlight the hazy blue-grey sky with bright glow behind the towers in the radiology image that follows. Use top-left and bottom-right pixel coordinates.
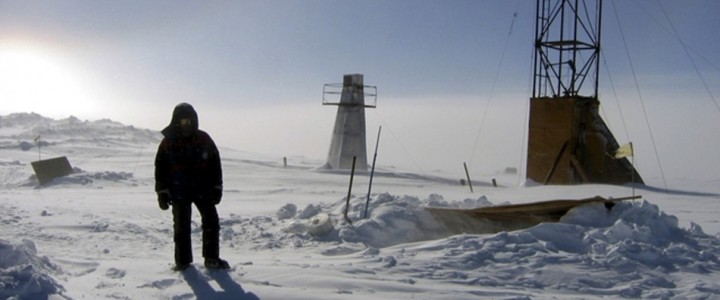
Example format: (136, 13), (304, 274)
(0, 0), (720, 185)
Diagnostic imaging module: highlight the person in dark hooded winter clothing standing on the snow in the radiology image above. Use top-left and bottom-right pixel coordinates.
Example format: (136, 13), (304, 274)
(155, 103), (229, 271)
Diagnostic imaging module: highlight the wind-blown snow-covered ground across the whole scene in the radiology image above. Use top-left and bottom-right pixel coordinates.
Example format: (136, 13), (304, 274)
(0, 114), (720, 299)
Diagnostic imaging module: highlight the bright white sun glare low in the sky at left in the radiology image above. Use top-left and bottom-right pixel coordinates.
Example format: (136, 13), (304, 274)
(0, 48), (95, 117)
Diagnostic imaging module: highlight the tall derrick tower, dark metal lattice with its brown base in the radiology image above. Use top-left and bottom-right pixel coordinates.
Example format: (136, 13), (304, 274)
(526, 0), (642, 184)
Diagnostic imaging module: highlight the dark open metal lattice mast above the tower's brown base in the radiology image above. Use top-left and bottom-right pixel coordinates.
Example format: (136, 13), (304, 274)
(533, 0), (602, 98)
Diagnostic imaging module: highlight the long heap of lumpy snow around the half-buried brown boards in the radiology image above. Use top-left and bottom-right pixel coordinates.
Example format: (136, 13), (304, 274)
(265, 193), (720, 264)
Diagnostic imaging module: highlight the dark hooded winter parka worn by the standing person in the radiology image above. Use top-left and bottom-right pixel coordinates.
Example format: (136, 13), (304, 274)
(155, 103), (223, 201)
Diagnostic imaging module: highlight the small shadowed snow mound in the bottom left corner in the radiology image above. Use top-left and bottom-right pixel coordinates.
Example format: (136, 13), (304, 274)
(0, 240), (64, 299)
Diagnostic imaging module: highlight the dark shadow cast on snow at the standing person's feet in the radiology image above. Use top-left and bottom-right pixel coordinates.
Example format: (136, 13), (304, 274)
(182, 267), (260, 300)
